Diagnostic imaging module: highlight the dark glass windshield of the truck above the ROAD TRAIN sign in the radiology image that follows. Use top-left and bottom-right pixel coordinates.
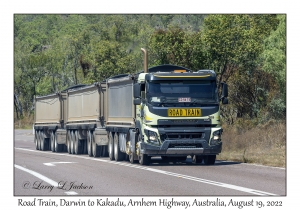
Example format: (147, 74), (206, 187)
(146, 80), (218, 106)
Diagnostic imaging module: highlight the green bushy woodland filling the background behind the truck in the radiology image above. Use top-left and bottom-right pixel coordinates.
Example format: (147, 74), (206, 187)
(14, 14), (286, 166)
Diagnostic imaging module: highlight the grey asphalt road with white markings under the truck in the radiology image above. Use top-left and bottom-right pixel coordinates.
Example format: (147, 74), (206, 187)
(14, 130), (286, 196)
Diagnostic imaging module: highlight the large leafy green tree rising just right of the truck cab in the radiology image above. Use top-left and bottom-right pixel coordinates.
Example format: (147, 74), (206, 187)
(203, 15), (278, 121)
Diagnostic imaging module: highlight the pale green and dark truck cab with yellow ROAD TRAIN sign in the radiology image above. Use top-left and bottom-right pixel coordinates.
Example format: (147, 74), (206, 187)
(133, 49), (228, 165)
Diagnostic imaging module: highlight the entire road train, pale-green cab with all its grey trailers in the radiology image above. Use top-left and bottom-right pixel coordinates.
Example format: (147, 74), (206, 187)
(34, 48), (228, 165)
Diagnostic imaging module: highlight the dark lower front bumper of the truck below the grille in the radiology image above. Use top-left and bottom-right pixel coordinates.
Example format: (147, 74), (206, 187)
(140, 139), (222, 156)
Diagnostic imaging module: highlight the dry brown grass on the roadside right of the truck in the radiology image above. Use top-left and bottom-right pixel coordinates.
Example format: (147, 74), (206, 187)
(217, 121), (286, 167)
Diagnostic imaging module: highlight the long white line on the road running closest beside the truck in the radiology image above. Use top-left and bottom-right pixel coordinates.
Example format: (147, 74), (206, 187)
(15, 148), (276, 196)
